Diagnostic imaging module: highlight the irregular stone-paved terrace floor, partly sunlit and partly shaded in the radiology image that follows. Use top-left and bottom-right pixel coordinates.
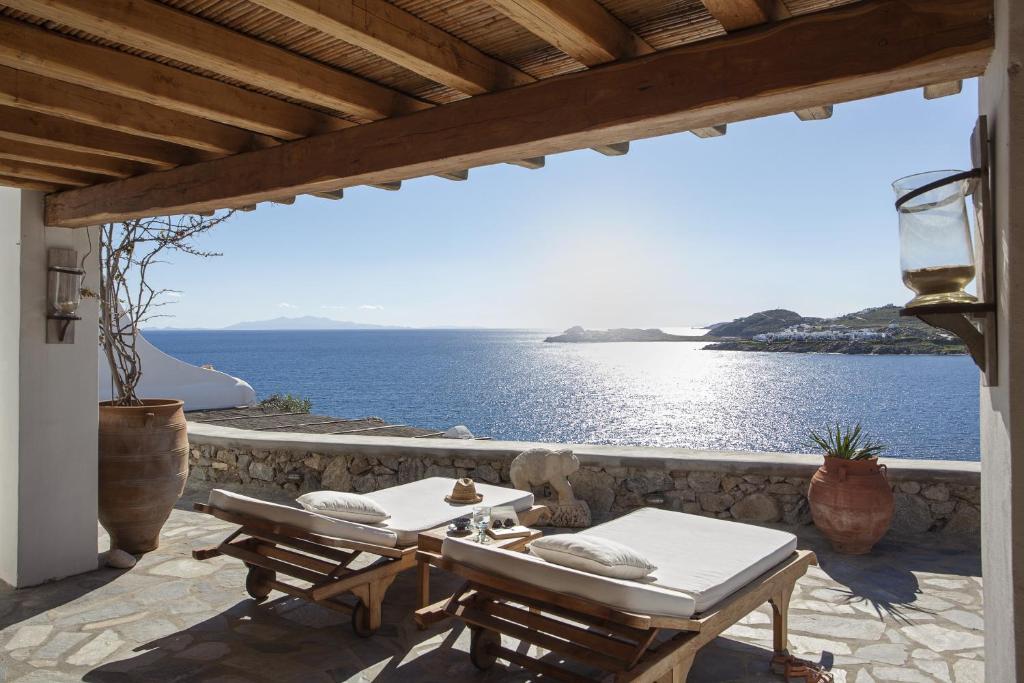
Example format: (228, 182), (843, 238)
(0, 489), (984, 683)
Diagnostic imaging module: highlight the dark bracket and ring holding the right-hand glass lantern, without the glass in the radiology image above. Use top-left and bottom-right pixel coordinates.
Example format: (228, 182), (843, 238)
(897, 116), (998, 386)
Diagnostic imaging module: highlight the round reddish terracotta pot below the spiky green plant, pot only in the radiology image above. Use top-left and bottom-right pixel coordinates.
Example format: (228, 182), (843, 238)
(807, 456), (893, 555)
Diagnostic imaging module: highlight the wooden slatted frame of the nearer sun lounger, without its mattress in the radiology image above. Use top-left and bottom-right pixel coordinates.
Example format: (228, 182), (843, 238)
(428, 550), (817, 683)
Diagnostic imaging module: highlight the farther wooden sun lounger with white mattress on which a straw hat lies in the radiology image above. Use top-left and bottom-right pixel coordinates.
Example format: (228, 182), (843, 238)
(193, 477), (546, 636)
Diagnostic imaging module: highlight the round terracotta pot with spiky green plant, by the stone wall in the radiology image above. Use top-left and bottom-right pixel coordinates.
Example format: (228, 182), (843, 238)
(807, 424), (893, 555)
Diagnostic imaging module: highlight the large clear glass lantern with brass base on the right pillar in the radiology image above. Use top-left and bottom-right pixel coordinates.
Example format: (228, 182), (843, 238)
(893, 171), (977, 307)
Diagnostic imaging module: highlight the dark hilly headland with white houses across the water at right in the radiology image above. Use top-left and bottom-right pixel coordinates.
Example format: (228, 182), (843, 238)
(545, 304), (965, 355)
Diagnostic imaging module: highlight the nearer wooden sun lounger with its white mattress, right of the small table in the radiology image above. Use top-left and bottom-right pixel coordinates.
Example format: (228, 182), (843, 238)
(428, 508), (827, 682)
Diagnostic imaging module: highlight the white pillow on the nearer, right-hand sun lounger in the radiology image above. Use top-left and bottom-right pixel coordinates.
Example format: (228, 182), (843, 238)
(529, 533), (657, 579)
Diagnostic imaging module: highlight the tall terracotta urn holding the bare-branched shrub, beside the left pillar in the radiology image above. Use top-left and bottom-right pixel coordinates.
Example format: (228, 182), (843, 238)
(99, 398), (188, 555)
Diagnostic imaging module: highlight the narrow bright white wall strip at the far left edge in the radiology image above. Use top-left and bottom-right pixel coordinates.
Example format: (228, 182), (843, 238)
(0, 187), (22, 584)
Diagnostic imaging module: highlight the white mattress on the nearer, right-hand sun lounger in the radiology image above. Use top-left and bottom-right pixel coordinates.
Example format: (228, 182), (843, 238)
(441, 508), (797, 618)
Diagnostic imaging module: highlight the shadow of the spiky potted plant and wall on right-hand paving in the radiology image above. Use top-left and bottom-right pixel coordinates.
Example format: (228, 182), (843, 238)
(801, 532), (981, 624)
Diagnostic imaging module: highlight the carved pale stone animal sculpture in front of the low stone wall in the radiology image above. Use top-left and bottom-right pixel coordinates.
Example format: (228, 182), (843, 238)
(509, 449), (591, 528)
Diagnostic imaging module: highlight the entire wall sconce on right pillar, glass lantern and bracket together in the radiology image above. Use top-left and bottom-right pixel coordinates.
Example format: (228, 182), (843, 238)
(893, 116), (998, 386)
